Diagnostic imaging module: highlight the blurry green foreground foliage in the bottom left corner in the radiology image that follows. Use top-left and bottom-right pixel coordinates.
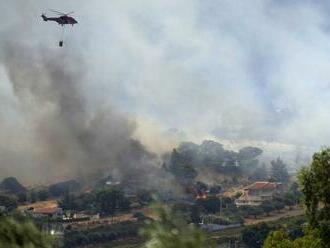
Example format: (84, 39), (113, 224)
(0, 217), (53, 248)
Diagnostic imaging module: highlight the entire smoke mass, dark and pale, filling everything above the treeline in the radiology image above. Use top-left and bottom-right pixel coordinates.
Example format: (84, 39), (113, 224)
(0, 0), (330, 182)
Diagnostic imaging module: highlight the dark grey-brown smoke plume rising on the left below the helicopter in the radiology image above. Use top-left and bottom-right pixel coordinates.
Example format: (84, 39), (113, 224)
(1, 43), (166, 186)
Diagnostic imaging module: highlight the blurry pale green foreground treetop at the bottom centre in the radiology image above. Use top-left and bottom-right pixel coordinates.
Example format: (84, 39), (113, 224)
(141, 205), (208, 248)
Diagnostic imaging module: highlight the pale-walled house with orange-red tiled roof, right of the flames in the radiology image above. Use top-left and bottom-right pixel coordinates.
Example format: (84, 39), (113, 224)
(235, 182), (282, 207)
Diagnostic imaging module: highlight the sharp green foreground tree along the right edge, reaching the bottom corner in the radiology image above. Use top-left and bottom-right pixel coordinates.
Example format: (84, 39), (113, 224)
(265, 148), (330, 248)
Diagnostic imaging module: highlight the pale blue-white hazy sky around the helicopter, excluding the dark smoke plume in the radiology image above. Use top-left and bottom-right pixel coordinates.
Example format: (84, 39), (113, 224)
(0, 0), (330, 180)
